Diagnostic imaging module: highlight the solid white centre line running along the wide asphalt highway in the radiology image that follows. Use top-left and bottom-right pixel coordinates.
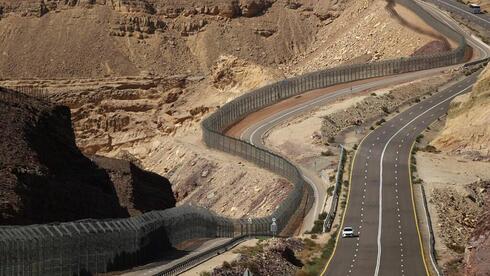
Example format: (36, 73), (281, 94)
(374, 84), (473, 276)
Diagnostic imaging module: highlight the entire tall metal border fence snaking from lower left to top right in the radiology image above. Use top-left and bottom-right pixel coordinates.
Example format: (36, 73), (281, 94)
(0, 0), (467, 276)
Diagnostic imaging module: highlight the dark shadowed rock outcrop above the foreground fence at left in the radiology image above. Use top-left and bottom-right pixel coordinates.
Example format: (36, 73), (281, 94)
(0, 91), (175, 224)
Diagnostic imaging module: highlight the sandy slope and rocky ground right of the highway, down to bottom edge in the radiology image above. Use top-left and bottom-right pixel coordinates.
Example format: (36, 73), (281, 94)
(417, 63), (490, 275)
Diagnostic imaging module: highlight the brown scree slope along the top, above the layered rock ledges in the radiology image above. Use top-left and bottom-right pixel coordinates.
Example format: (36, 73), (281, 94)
(0, 0), (444, 79)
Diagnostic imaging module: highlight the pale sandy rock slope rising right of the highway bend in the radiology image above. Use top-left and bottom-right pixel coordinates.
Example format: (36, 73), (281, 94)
(432, 65), (490, 160)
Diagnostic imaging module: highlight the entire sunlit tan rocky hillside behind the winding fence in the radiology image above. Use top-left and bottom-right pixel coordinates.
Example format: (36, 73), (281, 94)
(0, 0), (452, 220)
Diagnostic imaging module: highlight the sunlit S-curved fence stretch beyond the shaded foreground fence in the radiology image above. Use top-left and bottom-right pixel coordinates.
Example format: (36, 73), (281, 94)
(202, 0), (466, 239)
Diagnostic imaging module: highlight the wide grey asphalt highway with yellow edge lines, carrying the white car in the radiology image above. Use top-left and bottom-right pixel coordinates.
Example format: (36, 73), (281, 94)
(326, 71), (476, 275)
